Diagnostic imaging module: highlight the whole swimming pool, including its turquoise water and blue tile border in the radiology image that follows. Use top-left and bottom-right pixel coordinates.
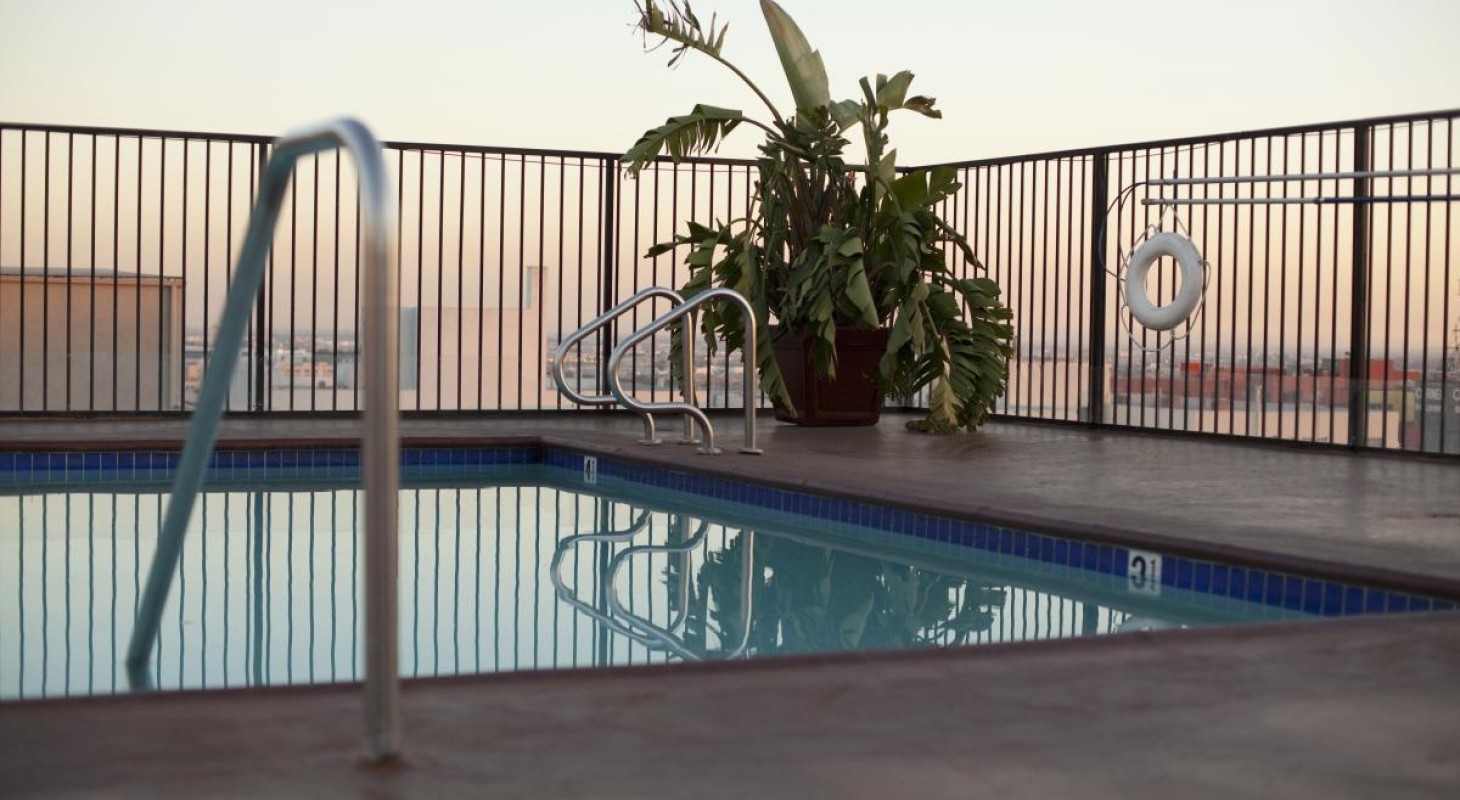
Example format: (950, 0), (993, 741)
(0, 447), (1453, 699)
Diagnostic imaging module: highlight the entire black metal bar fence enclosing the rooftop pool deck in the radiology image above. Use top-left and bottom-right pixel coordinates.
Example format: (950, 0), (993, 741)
(0, 111), (1460, 454)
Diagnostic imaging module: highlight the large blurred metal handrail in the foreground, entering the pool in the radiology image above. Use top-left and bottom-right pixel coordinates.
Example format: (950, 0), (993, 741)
(127, 120), (400, 761)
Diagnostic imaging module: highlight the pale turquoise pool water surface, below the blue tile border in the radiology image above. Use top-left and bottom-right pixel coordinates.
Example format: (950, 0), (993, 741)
(0, 466), (1298, 699)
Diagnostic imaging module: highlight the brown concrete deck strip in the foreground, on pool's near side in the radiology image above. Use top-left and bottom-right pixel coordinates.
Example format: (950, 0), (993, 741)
(0, 615), (1460, 800)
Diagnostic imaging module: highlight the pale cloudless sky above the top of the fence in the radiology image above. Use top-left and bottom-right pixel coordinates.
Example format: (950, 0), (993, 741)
(0, 0), (1460, 165)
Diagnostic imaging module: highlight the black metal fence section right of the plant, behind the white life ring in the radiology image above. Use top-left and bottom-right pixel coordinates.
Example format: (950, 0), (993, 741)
(949, 112), (1460, 454)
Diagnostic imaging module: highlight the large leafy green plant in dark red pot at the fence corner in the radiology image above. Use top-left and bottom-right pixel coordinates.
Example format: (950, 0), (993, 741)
(623, 0), (1013, 432)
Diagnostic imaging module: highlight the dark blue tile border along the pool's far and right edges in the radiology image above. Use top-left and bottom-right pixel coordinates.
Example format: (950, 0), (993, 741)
(0, 445), (1457, 616)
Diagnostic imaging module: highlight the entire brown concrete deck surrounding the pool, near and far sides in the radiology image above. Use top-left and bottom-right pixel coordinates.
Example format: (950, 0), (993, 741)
(0, 415), (1460, 799)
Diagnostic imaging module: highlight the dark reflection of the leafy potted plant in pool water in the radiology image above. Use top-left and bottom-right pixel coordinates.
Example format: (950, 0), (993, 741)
(669, 534), (1004, 655)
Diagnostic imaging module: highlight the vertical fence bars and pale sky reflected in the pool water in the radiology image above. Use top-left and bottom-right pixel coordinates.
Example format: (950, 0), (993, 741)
(0, 486), (1156, 698)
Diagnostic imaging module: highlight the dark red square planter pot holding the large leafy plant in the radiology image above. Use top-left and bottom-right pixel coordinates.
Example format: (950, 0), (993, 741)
(774, 328), (888, 425)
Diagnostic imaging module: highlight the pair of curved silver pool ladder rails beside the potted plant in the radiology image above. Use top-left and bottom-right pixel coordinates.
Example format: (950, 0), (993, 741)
(552, 286), (765, 455)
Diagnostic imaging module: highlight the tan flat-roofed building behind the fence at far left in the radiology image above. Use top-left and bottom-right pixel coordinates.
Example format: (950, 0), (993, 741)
(0, 267), (183, 412)
